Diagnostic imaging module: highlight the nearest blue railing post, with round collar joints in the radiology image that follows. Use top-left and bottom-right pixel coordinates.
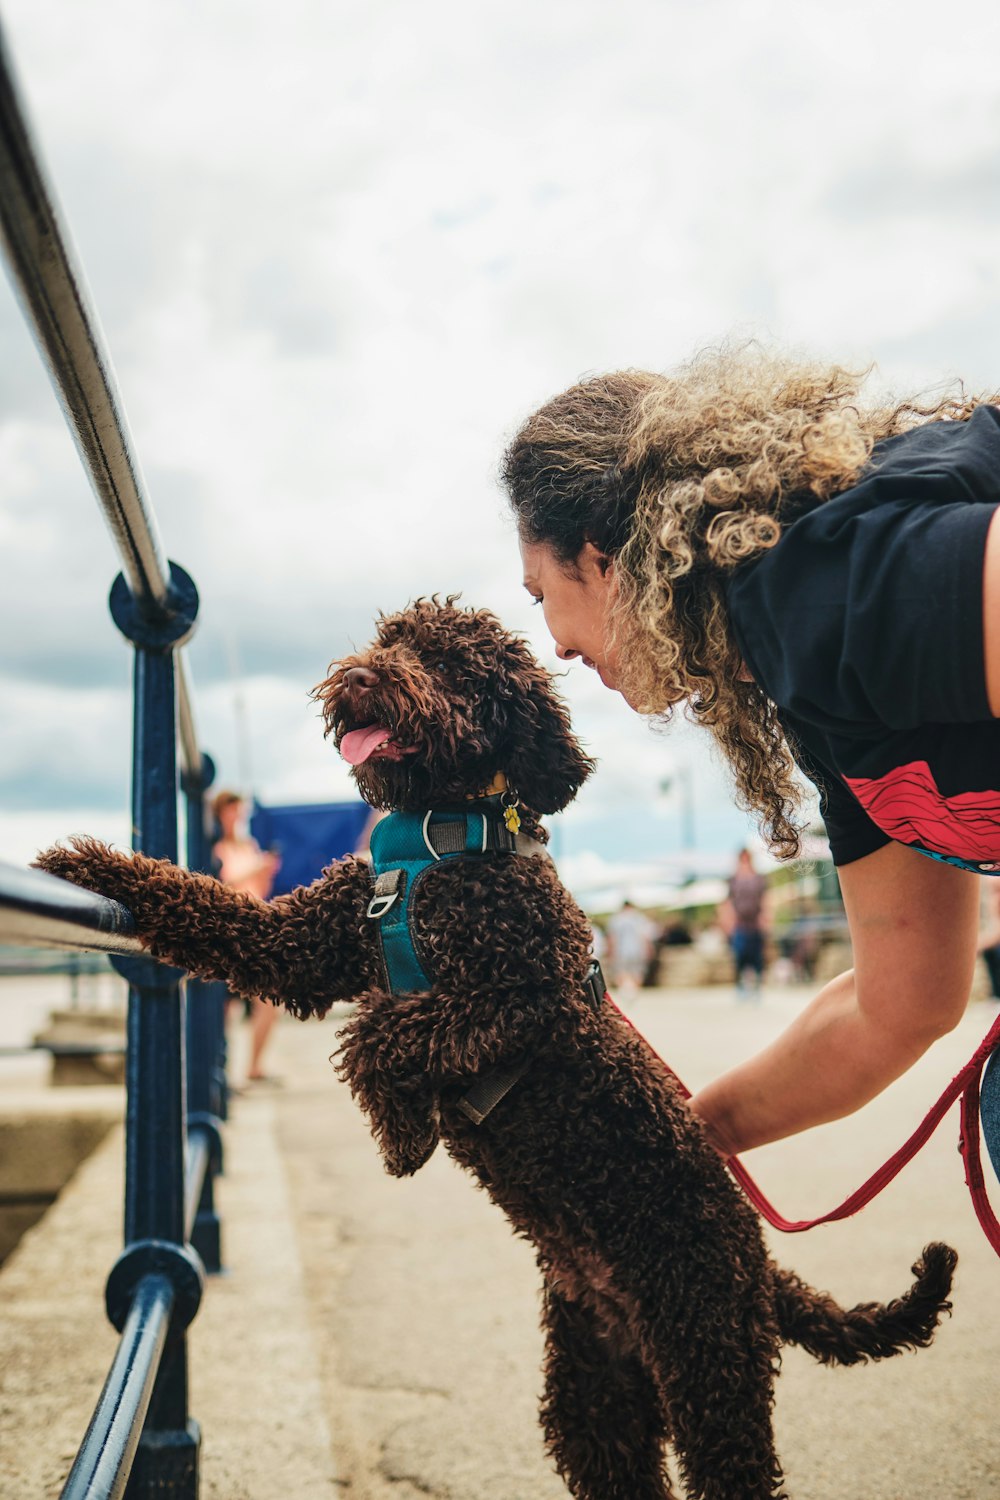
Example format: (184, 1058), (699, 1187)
(108, 564), (201, 1500)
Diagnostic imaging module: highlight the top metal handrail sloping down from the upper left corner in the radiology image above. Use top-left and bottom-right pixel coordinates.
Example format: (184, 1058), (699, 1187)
(0, 30), (201, 774)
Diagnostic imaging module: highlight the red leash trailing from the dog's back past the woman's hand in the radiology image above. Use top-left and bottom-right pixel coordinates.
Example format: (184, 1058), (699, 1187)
(607, 995), (1000, 1256)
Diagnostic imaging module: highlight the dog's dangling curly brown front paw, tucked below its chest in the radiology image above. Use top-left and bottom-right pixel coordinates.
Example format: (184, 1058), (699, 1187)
(334, 998), (439, 1178)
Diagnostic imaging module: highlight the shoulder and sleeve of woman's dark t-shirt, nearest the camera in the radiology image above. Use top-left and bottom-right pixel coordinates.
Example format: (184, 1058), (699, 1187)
(727, 407), (1000, 734)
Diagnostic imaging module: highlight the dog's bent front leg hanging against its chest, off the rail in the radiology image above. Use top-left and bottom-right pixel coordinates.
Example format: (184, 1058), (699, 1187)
(336, 990), (438, 1178)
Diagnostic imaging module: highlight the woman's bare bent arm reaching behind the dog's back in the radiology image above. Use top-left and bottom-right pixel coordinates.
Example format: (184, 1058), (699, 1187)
(691, 843), (979, 1155)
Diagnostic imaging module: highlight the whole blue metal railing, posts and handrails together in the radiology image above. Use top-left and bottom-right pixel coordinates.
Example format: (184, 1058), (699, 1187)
(0, 23), (225, 1500)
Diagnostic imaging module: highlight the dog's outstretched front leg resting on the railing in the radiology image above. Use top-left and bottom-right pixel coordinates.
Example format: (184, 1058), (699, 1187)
(36, 839), (376, 1017)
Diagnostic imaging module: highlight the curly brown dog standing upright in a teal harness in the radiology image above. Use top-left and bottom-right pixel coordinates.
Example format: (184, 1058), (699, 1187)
(39, 600), (955, 1500)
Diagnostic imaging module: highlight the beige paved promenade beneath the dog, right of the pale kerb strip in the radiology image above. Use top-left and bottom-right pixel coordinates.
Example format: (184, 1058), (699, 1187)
(265, 990), (1000, 1500)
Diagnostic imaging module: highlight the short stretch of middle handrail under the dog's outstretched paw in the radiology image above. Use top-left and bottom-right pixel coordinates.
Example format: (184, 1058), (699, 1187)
(0, 863), (147, 954)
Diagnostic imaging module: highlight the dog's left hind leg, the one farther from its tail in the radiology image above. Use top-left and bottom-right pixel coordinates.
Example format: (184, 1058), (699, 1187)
(541, 1283), (673, 1500)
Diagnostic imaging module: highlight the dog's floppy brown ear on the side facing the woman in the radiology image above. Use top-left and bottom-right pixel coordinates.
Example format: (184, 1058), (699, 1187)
(493, 641), (597, 813)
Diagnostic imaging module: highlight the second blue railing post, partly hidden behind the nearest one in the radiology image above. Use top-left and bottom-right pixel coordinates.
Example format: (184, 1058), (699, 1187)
(181, 756), (225, 1271)
